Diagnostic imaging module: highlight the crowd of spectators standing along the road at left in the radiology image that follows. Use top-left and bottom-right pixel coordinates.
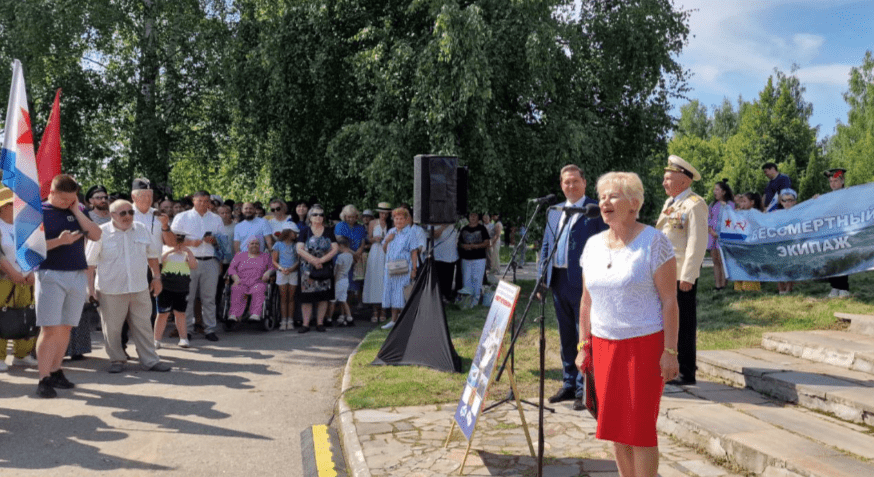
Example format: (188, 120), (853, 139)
(0, 174), (510, 398)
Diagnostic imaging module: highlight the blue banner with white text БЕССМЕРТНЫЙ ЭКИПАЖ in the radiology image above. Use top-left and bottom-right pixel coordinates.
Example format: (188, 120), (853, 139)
(719, 183), (874, 282)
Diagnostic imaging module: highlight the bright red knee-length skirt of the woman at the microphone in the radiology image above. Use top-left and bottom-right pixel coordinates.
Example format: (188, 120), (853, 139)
(592, 331), (665, 447)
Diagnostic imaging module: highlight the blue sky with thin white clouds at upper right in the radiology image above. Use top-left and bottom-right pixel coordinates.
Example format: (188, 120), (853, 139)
(674, 0), (874, 137)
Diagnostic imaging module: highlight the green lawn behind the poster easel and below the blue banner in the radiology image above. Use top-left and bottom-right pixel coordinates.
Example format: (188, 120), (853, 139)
(346, 268), (874, 409)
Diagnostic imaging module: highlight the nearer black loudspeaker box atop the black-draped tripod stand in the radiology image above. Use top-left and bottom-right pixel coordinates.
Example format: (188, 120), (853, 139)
(413, 154), (458, 224)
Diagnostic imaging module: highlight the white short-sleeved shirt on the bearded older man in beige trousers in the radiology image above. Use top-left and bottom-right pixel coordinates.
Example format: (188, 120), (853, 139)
(85, 221), (161, 295)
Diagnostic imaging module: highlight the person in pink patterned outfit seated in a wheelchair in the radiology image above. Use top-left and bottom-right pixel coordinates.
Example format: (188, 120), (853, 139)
(228, 235), (273, 328)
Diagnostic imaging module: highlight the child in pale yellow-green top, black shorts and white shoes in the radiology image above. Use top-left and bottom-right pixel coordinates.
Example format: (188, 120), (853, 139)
(155, 230), (197, 349)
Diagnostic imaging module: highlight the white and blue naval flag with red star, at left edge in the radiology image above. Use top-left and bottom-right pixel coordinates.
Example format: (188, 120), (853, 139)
(0, 60), (46, 272)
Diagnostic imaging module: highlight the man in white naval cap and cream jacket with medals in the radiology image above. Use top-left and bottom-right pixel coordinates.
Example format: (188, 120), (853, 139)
(656, 155), (708, 385)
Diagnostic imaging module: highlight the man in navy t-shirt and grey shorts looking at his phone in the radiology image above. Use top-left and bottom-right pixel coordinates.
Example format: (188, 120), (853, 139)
(35, 174), (101, 398)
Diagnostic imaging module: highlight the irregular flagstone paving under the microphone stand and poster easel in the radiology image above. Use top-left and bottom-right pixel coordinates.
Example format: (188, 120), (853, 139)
(340, 358), (739, 477)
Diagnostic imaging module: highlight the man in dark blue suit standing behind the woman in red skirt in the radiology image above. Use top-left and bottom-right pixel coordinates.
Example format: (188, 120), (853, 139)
(538, 164), (607, 411)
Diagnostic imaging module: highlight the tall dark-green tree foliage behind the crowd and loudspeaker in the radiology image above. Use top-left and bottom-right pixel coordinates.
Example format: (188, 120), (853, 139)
(0, 0), (688, 218)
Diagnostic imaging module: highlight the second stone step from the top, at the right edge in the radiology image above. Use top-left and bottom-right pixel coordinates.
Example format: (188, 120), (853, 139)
(762, 330), (874, 374)
